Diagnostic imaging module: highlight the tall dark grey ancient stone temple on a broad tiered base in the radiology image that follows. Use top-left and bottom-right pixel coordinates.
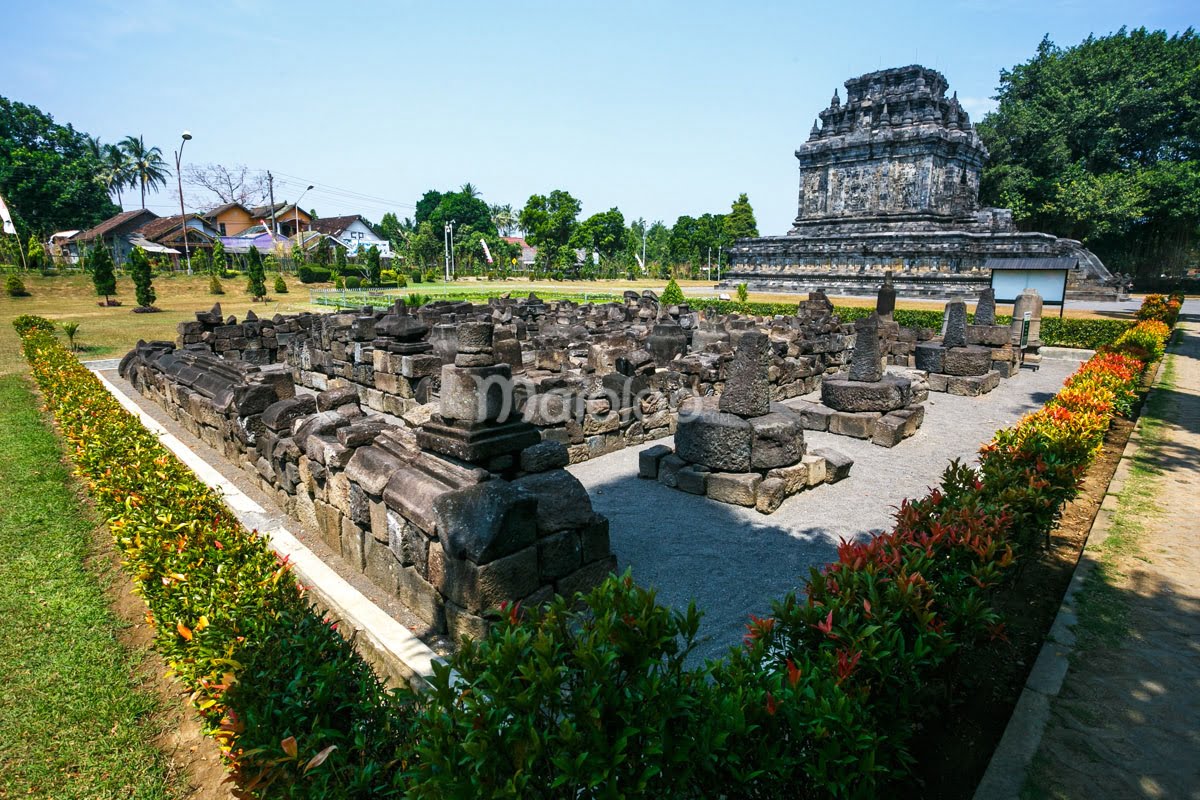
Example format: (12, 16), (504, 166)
(726, 65), (1115, 297)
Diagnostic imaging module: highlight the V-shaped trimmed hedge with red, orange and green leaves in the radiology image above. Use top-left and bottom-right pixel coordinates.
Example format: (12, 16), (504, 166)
(11, 297), (1165, 799)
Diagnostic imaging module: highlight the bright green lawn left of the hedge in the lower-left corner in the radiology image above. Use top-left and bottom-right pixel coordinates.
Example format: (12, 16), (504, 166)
(0, 376), (179, 800)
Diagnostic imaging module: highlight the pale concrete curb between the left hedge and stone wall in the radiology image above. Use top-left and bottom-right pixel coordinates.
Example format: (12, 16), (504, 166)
(85, 365), (443, 690)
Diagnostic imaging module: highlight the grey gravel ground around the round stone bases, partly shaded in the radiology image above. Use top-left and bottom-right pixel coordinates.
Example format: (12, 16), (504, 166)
(569, 360), (1078, 657)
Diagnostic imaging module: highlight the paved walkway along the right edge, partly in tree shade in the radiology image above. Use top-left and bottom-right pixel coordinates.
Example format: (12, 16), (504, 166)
(1021, 316), (1200, 800)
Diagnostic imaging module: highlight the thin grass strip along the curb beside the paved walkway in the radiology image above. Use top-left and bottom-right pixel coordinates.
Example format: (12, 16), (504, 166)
(1072, 347), (1175, 662)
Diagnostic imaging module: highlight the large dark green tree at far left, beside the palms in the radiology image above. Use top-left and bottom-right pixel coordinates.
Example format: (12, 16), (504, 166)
(0, 97), (120, 234)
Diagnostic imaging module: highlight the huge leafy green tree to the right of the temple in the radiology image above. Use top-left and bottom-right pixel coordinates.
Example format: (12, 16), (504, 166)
(978, 28), (1200, 275)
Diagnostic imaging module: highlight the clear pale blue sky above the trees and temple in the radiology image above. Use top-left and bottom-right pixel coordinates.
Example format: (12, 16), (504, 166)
(0, 0), (1196, 234)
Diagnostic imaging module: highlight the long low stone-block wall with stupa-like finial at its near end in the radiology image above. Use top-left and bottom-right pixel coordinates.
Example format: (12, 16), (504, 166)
(120, 320), (617, 637)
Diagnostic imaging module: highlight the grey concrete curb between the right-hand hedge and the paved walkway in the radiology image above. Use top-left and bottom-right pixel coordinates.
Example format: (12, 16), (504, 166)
(974, 350), (1170, 800)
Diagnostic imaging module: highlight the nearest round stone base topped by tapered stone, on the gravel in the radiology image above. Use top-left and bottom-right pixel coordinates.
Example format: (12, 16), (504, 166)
(638, 331), (853, 513)
